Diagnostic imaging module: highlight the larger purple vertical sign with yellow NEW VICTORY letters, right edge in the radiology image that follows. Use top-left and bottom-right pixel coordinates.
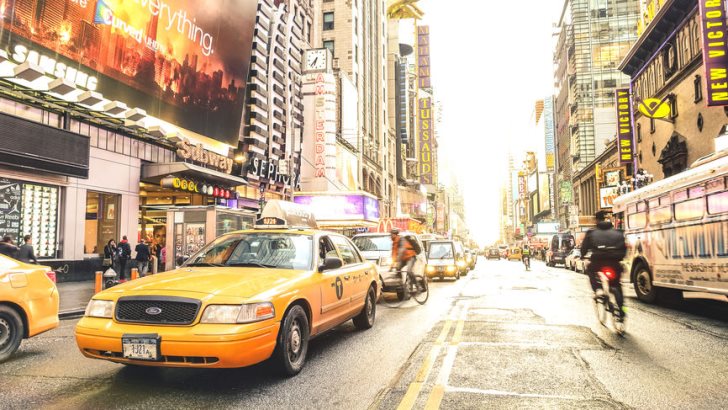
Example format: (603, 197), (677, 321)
(698, 0), (728, 107)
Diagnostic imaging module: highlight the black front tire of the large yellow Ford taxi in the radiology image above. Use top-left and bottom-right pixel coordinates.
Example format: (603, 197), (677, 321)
(273, 305), (310, 376)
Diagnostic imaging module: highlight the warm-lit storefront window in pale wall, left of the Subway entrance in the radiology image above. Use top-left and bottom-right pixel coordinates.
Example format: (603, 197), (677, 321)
(83, 191), (120, 255)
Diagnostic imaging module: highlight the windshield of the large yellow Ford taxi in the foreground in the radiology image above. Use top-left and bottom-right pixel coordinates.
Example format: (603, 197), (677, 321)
(183, 232), (313, 270)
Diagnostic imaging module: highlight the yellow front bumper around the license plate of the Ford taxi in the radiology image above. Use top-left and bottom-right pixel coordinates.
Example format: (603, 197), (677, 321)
(76, 317), (280, 368)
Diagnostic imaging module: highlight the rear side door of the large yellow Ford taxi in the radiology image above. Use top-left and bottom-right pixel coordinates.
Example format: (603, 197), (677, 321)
(331, 235), (370, 313)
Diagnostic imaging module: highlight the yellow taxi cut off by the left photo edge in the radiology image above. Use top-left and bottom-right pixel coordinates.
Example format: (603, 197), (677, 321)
(0, 255), (58, 363)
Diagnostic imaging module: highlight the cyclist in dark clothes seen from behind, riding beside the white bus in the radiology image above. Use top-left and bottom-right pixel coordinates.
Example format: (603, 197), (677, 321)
(581, 211), (627, 317)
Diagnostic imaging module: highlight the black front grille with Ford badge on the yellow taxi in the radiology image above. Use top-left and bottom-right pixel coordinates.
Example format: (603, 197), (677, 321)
(115, 296), (201, 325)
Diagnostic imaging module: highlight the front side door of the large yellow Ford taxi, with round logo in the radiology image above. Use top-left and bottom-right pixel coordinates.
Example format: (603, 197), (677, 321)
(318, 236), (351, 330)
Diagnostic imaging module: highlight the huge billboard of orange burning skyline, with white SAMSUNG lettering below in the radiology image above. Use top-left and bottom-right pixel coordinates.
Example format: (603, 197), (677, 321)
(0, 0), (257, 145)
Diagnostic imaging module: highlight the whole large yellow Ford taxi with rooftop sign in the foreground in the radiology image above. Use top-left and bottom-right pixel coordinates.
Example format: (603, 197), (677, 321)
(76, 200), (380, 375)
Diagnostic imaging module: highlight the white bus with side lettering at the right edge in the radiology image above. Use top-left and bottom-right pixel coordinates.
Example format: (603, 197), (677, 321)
(613, 150), (728, 303)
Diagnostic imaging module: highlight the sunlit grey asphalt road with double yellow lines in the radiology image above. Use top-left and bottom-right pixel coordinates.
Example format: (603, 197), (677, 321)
(0, 259), (728, 409)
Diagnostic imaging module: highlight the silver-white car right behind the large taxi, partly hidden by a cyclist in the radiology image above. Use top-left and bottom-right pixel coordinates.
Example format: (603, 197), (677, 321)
(352, 232), (427, 296)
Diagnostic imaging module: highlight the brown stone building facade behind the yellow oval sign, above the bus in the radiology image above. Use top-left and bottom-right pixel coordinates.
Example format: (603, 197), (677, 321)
(620, 0), (728, 180)
